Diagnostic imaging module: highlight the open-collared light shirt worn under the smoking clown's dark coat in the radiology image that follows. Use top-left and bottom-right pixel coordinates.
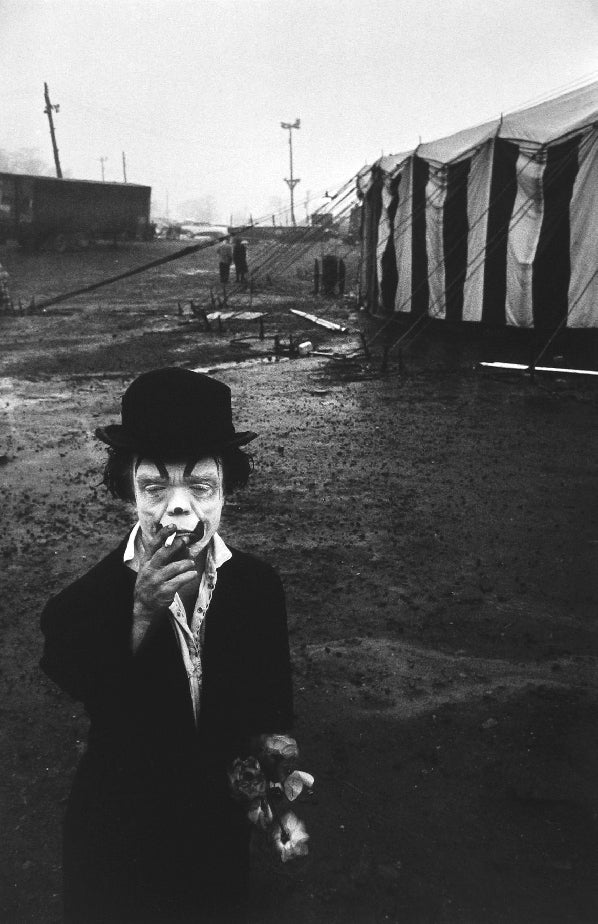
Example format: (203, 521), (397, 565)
(123, 523), (232, 725)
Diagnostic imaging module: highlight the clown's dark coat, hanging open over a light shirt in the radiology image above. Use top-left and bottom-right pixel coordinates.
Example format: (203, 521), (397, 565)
(41, 542), (292, 924)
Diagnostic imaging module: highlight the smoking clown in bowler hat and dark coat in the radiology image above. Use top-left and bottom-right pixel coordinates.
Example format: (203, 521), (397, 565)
(41, 369), (292, 924)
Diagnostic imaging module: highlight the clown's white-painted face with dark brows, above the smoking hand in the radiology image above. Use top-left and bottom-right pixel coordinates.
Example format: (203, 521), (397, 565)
(133, 458), (224, 558)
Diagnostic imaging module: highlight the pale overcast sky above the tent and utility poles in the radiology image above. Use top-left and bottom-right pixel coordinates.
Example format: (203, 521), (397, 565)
(0, 0), (598, 222)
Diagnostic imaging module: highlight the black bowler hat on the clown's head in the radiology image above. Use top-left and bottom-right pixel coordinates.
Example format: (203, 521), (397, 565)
(96, 368), (257, 459)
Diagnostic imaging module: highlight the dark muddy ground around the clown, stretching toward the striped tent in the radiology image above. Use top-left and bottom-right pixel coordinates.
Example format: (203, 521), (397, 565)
(0, 243), (598, 924)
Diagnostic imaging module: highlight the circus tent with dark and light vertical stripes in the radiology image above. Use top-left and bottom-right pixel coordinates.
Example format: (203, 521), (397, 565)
(358, 82), (598, 330)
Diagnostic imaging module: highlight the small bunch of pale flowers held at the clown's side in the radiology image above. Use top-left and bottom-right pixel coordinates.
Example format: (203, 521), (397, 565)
(228, 735), (314, 863)
